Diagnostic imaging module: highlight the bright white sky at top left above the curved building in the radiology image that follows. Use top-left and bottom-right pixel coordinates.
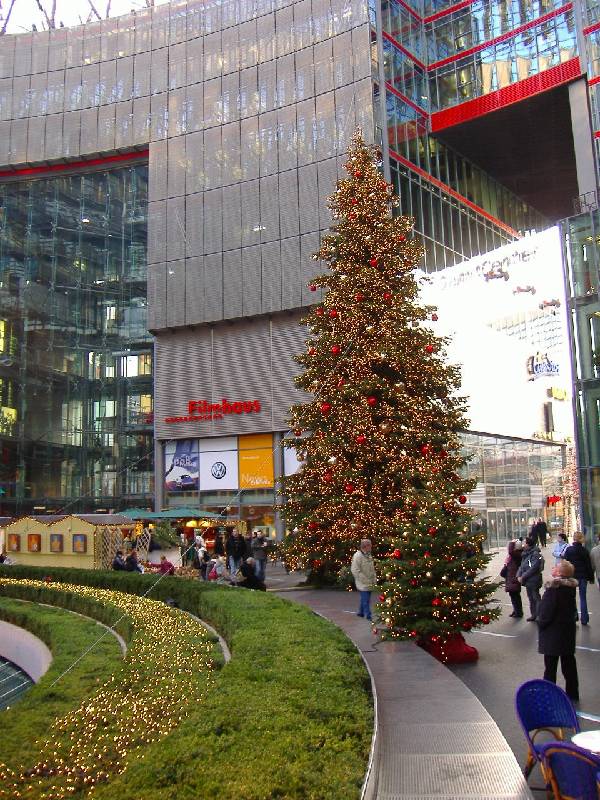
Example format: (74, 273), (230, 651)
(2, 0), (166, 33)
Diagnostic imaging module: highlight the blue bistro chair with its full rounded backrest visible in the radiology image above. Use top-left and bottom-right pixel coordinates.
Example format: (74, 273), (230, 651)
(515, 679), (579, 787)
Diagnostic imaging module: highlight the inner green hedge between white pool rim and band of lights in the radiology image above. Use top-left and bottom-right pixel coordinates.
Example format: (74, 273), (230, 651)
(0, 597), (123, 768)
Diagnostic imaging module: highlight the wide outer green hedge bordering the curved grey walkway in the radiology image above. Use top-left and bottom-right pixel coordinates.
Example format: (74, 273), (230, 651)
(0, 566), (373, 800)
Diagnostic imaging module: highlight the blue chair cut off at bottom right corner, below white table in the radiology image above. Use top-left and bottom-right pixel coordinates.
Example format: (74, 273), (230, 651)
(539, 742), (600, 800)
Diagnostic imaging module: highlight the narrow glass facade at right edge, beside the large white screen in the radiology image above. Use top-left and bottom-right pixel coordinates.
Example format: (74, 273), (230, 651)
(562, 210), (600, 535)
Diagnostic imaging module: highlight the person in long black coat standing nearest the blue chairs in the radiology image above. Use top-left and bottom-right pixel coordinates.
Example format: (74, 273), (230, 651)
(538, 561), (579, 702)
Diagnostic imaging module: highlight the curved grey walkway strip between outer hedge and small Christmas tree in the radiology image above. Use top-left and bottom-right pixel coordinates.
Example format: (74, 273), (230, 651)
(284, 590), (532, 800)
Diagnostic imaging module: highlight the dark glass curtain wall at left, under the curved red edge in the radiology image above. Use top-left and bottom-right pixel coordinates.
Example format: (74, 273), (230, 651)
(0, 164), (153, 515)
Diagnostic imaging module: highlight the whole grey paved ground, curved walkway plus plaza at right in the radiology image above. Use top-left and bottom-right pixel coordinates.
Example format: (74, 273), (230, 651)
(267, 547), (600, 800)
